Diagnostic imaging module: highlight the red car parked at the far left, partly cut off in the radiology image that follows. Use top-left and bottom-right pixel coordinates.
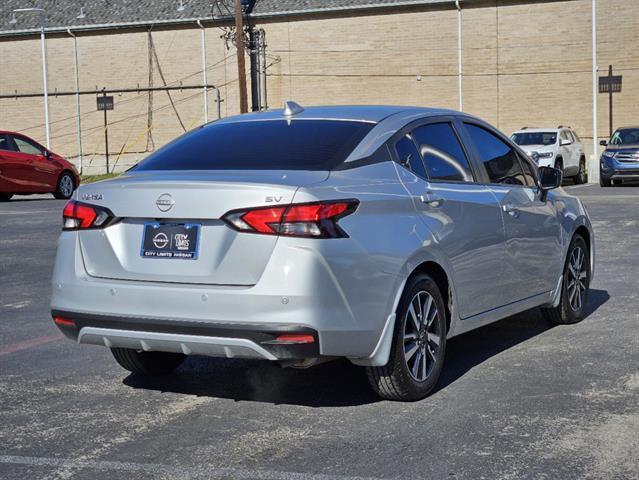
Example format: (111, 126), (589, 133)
(0, 130), (80, 201)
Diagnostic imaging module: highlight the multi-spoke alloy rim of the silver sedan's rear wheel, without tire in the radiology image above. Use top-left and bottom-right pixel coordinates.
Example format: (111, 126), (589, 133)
(403, 290), (441, 382)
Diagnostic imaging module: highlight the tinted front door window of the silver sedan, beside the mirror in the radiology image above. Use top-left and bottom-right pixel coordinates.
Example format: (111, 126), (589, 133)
(466, 123), (526, 185)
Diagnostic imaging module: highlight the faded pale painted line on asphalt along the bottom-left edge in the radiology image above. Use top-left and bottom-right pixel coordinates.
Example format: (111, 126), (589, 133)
(0, 455), (380, 480)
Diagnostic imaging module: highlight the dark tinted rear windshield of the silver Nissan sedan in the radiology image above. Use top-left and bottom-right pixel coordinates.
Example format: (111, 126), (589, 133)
(133, 119), (374, 170)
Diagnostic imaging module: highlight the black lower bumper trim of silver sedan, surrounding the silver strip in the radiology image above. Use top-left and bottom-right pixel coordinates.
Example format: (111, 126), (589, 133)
(51, 310), (320, 360)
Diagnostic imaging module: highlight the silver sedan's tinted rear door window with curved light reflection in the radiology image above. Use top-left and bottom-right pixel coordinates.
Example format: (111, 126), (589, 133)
(413, 123), (473, 182)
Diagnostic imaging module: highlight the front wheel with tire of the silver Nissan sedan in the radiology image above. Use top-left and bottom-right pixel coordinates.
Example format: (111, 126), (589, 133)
(541, 235), (590, 325)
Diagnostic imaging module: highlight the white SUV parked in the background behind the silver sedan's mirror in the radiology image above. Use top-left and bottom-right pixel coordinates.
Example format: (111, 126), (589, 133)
(511, 125), (588, 184)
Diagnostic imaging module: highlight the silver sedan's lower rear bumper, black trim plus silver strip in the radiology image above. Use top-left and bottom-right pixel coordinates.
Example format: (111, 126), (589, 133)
(51, 310), (320, 360)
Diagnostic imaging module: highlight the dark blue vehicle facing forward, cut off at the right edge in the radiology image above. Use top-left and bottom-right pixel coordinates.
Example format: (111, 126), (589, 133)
(599, 127), (639, 187)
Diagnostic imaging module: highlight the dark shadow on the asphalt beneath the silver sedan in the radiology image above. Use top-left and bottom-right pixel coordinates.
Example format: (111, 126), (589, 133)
(123, 290), (610, 408)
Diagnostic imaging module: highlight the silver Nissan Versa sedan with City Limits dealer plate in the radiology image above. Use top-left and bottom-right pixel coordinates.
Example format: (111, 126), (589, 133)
(51, 104), (594, 400)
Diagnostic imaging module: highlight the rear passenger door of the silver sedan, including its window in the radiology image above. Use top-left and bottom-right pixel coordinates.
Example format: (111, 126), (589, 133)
(391, 119), (505, 318)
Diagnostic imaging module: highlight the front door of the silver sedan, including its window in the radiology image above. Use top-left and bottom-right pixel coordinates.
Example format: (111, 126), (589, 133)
(465, 122), (561, 301)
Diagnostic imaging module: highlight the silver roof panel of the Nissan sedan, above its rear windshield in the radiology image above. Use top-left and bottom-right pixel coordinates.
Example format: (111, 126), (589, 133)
(215, 105), (459, 123)
